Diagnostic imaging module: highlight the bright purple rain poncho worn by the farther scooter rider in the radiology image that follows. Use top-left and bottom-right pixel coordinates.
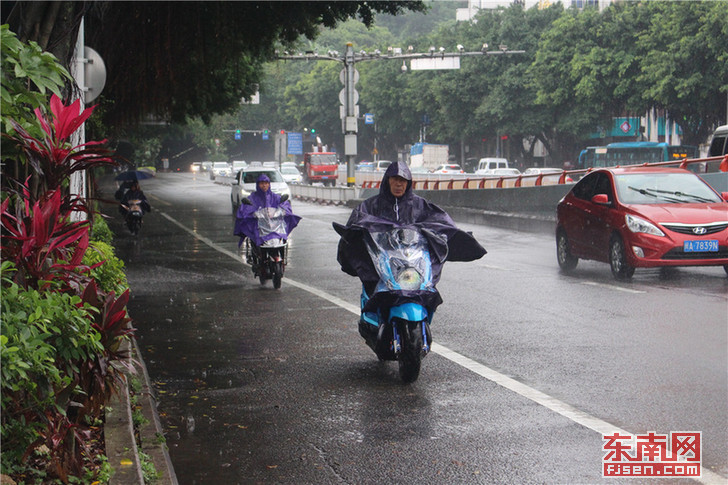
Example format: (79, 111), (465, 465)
(234, 174), (301, 246)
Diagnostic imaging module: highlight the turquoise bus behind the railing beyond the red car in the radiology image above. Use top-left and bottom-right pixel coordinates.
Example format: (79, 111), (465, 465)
(578, 141), (700, 169)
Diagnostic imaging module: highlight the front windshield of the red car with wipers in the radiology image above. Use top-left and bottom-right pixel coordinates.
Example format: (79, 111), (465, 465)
(615, 173), (721, 204)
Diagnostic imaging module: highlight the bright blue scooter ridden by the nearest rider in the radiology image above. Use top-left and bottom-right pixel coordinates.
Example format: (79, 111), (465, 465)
(359, 228), (432, 383)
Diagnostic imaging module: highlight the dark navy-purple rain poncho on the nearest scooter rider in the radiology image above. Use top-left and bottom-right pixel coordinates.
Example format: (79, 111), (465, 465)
(333, 162), (486, 306)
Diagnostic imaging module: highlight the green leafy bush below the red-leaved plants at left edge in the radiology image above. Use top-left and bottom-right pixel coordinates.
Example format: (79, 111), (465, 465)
(0, 262), (104, 469)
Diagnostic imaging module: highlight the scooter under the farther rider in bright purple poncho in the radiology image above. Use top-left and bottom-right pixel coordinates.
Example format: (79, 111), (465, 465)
(242, 199), (288, 290)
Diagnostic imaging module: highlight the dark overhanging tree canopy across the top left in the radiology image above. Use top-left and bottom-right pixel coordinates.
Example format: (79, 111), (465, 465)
(2, 1), (426, 129)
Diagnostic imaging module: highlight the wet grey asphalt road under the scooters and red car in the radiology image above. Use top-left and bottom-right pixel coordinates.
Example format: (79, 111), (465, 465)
(102, 174), (728, 484)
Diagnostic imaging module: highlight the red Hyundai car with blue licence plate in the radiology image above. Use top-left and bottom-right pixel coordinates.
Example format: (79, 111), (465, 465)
(556, 166), (728, 279)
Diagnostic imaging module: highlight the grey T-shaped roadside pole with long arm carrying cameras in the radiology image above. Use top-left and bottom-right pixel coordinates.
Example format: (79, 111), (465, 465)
(276, 42), (525, 187)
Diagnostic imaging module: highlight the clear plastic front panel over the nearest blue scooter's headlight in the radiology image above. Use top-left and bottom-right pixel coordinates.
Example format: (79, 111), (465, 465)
(367, 228), (435, 292)
